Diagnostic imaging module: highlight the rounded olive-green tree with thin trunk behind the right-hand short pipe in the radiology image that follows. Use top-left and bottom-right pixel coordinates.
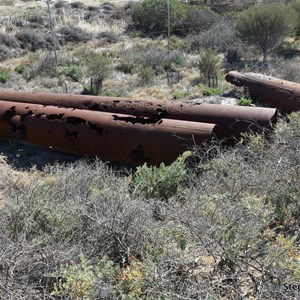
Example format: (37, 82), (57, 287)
(236, 3), (294, 63)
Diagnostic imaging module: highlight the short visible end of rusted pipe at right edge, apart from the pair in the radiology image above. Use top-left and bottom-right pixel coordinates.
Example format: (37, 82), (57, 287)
(226, 71), (300, 113)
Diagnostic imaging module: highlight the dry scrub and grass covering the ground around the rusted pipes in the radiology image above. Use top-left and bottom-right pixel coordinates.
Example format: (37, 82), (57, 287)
(0, 0), (300, 300)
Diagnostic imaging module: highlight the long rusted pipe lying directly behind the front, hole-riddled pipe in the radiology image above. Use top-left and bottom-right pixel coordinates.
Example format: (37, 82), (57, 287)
(0, 91), (277, 138)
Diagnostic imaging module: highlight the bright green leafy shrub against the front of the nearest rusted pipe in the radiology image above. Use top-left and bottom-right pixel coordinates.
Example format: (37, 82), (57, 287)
(133, 152), (190, 199)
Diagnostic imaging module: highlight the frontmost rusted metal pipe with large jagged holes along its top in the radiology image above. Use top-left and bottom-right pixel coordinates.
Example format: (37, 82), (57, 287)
(0, 101), (217, 165)
